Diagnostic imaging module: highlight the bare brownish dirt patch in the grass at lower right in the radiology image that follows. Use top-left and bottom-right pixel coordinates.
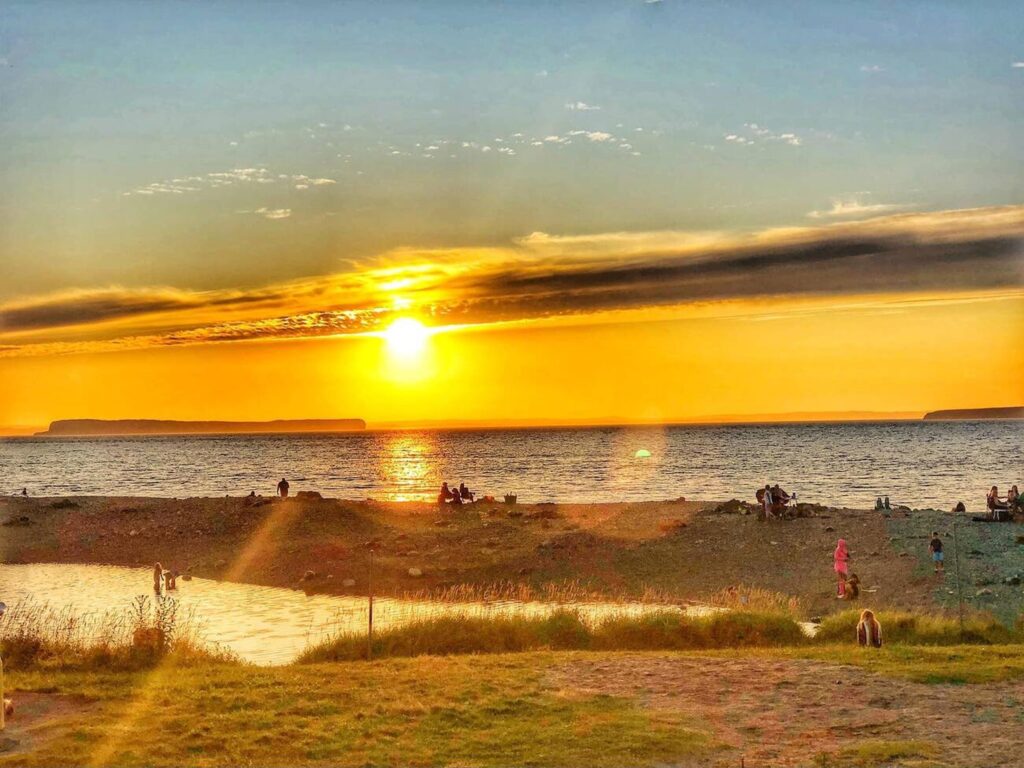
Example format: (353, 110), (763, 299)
(549, 654), (1024, 768)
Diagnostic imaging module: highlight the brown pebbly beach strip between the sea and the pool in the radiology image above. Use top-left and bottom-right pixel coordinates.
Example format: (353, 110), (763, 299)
(0, 497), (1024, 618)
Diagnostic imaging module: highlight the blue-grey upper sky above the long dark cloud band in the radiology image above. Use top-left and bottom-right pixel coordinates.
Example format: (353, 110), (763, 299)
(0, 0), (1024, 299)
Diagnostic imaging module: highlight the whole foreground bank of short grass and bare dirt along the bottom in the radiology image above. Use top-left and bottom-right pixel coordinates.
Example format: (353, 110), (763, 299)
(0, 645), (1024, 766)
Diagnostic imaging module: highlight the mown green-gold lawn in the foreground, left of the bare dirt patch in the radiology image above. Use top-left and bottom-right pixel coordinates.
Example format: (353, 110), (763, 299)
(0, 654), (715, 766)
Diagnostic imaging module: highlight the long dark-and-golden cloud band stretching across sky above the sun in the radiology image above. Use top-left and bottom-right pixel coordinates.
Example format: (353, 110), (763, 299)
(0, 206), (1024, 356)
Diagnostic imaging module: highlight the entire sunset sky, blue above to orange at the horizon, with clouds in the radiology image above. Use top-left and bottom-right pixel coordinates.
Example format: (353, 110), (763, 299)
(0, 0), (1024, 427)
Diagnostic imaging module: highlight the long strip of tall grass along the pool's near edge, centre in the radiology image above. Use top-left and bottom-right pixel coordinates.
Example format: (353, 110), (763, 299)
(299, 610), (808, 664)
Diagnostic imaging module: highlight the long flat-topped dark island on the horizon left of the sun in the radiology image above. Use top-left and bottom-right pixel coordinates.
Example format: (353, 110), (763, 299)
(37, 419), (367, 435)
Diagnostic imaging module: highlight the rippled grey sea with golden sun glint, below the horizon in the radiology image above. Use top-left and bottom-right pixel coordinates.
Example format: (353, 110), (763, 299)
(0, 421), (1024, 510)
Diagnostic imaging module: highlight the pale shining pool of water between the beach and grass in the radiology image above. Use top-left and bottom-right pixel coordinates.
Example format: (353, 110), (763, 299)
(0, 563), (698, 665)
